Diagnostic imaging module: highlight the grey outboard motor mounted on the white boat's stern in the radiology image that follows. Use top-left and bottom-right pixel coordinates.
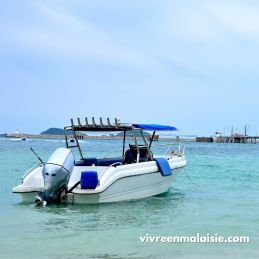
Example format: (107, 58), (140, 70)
(35, 148), (74, 205)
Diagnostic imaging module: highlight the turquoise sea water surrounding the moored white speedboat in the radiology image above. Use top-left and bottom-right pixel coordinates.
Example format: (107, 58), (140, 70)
(0, 139), (259, 259)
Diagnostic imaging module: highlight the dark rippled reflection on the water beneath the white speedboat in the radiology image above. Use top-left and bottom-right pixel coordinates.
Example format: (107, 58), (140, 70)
(14, 189), (185, 235)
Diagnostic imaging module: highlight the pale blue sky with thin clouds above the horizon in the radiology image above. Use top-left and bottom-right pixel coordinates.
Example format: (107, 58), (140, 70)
(0, 0), (259, 136)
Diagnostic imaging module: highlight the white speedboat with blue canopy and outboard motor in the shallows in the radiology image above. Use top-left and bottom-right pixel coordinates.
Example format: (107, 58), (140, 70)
(12, 118), (187, 204)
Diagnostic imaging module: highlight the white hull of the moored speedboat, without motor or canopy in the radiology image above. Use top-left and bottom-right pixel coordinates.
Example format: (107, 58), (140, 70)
(13, 156), (186, 204)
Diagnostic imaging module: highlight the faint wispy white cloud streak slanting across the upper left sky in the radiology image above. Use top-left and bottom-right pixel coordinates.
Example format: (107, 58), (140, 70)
(2, 2), (161, 68)
